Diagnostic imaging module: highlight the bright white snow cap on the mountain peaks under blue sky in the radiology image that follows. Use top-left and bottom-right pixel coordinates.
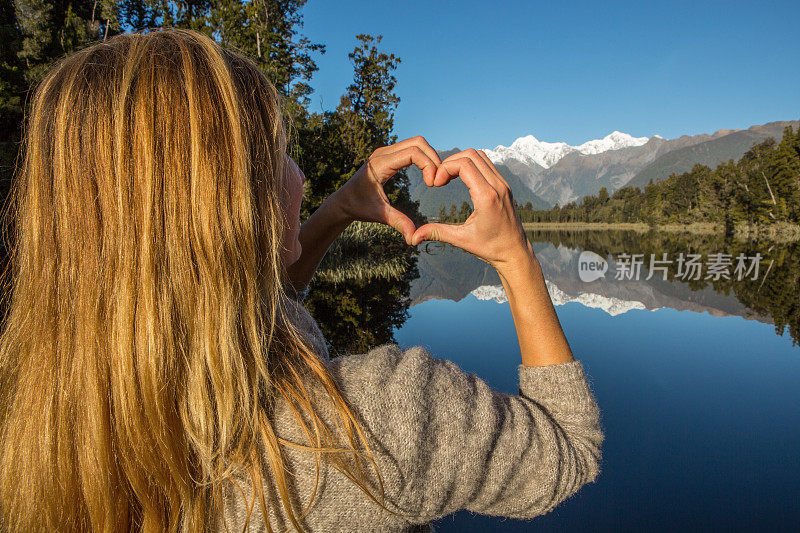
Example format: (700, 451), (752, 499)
(484, 131), (661, 168)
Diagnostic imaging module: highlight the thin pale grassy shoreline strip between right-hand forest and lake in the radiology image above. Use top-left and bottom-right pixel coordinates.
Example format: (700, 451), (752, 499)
(522, 222), (800, 242)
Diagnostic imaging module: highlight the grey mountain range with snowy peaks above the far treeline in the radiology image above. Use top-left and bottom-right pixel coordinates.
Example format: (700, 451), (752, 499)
(408, 120), (800, 217)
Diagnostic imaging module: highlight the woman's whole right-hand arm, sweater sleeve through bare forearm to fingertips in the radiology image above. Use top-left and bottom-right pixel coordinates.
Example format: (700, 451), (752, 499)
(324, 150), (603, 522)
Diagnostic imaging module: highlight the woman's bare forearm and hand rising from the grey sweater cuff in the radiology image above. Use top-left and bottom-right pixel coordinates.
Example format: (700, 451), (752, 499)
(412, 149), (574, 366)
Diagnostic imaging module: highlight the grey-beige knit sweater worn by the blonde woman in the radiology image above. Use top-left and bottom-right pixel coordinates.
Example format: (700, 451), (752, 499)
(220, 298), (603, 532)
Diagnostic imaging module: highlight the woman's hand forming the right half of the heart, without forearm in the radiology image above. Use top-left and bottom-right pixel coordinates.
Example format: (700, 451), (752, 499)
(411, 149), (533, 272)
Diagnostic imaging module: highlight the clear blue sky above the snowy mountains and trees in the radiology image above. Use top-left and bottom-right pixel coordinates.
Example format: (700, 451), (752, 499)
(303, 0), (800, 149)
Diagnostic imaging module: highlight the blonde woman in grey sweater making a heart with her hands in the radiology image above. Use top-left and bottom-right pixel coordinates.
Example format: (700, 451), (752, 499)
(0, 30), (602, 531)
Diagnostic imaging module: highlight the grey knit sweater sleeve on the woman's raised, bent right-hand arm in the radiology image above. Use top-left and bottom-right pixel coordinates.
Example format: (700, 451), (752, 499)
(332, 344), (603, 523)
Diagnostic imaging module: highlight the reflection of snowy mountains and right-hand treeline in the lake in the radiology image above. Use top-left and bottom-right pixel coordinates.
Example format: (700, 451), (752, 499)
(410, 231), (800, 343)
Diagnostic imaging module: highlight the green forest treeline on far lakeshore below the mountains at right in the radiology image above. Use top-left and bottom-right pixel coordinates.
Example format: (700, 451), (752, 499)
(440, 126), (800, 229)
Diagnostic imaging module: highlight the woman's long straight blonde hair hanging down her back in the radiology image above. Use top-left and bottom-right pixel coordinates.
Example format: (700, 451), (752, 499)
(0, 30), (383, 531)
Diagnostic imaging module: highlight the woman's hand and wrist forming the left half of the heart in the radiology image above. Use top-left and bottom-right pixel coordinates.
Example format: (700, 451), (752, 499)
(329, 136), (441, 244)
